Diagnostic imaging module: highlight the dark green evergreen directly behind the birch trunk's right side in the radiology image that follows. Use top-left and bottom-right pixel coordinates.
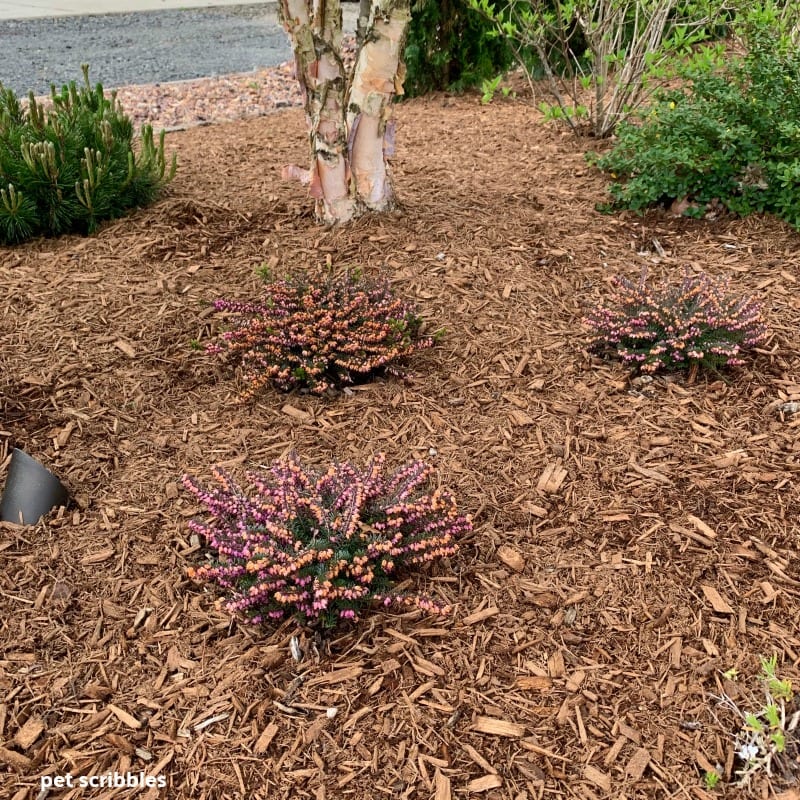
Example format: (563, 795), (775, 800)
(403, 0), (514, 97)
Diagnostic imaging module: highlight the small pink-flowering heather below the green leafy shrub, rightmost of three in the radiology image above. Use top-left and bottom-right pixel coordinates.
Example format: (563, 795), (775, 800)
(584, 269), (766, 372)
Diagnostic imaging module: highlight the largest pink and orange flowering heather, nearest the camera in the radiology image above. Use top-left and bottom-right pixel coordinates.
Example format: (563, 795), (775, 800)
(183, 454), (472, 627)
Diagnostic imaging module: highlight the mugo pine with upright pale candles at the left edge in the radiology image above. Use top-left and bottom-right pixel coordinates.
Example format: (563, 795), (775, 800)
(0, 65), (175, 244)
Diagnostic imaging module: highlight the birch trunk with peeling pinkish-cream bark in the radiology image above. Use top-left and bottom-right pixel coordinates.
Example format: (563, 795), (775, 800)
(279, 0), (411, 223)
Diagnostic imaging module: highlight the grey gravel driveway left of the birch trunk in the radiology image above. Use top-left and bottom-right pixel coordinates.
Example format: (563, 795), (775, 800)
(0, 3), (291, 95)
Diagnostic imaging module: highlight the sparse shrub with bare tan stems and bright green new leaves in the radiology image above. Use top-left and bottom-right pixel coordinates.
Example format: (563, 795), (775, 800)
(464, 0), (724, 137)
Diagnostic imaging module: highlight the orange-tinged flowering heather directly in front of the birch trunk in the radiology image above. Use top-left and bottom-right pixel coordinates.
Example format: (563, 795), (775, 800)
(206, 273), (433, 398)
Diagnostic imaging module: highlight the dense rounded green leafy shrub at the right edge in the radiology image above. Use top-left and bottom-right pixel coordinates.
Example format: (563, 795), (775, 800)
(590, 16), (800, 229)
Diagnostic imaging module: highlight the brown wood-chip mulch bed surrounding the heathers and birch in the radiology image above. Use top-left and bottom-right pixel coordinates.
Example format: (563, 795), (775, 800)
(0, 87), (800, 800)
